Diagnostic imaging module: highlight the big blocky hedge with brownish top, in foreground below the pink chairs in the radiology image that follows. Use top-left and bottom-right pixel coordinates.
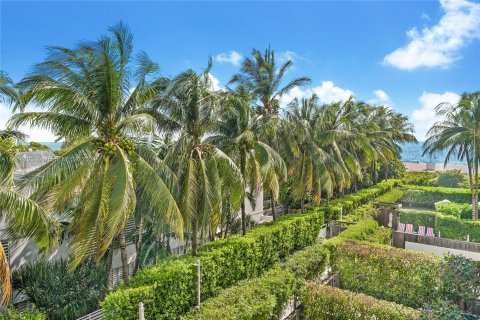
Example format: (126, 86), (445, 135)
(333, 242), (440, 308)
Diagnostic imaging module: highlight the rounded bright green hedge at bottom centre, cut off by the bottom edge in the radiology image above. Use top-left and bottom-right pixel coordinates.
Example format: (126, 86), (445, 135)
(181, 269), (297, 320)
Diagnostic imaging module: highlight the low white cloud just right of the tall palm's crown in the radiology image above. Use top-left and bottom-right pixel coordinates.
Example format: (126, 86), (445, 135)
(281, 81), (354, 107)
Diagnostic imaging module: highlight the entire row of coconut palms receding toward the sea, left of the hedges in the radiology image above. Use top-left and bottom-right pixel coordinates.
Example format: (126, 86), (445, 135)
(0, 23), (415, 292)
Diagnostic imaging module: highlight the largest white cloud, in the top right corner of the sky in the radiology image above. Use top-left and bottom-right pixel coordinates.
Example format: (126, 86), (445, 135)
(383, 0), (480, 70)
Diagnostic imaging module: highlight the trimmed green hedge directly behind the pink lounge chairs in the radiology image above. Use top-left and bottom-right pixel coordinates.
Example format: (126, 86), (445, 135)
(400, 209), (480, 243)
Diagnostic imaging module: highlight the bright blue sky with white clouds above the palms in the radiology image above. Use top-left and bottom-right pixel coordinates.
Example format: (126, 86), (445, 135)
(0, 0), (480, 141)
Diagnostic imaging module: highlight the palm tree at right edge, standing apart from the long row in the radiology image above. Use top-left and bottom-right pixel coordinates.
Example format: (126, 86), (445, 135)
(423, 92), (480, 219)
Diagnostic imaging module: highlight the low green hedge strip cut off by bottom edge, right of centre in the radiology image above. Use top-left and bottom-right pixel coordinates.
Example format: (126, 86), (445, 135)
(301, 283), (420, 320)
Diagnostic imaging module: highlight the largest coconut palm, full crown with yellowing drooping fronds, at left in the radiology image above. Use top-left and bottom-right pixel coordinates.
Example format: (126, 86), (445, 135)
(9, 23), (183, 284)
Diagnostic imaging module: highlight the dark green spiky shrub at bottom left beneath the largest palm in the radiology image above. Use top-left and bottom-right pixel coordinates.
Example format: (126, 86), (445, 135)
(13, 260), (108, 319)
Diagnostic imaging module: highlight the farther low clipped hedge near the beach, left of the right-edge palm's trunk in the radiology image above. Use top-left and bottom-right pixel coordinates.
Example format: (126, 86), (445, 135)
(402, 185), (472, 209)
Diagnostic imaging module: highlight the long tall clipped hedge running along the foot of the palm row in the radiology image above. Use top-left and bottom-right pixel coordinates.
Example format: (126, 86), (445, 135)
(101, 180), (398, 319)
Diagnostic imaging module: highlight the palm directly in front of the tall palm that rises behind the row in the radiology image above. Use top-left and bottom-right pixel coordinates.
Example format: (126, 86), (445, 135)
(206, 88), (286, 235)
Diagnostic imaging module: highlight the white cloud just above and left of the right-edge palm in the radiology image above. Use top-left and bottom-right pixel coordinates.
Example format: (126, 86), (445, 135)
(410, 91), (460, 141)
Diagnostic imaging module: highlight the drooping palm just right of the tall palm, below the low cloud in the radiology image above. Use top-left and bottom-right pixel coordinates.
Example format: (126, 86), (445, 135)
(285, 95), (343, 212)
